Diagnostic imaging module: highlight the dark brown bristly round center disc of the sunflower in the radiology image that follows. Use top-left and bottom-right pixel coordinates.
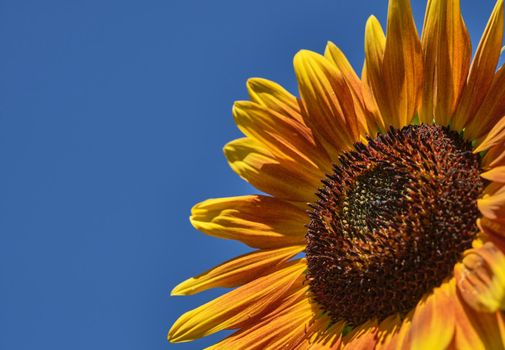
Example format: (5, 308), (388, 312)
(306, 125), (484, 326)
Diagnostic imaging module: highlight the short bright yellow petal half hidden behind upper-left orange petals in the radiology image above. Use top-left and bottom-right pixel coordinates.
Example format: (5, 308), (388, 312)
(247, 78), (305, 124)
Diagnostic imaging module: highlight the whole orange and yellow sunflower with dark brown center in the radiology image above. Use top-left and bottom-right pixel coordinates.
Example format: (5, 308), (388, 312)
(168, 0), (505, 349)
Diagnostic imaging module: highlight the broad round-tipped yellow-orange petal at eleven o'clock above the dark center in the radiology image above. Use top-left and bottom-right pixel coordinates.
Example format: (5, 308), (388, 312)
(294, 50), (361, 160)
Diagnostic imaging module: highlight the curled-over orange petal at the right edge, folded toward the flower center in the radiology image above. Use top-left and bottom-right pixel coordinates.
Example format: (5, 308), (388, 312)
(454, 242), (505, 312)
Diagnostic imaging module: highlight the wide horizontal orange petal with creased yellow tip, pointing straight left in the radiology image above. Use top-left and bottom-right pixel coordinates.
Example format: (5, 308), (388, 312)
(190, 195), (308, 249)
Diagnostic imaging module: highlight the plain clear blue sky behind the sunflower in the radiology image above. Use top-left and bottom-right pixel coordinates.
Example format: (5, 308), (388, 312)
(0, 0), (494, 350)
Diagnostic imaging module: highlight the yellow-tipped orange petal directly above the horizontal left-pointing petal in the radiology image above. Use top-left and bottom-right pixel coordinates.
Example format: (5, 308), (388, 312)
(224, 138), (320, 202)
